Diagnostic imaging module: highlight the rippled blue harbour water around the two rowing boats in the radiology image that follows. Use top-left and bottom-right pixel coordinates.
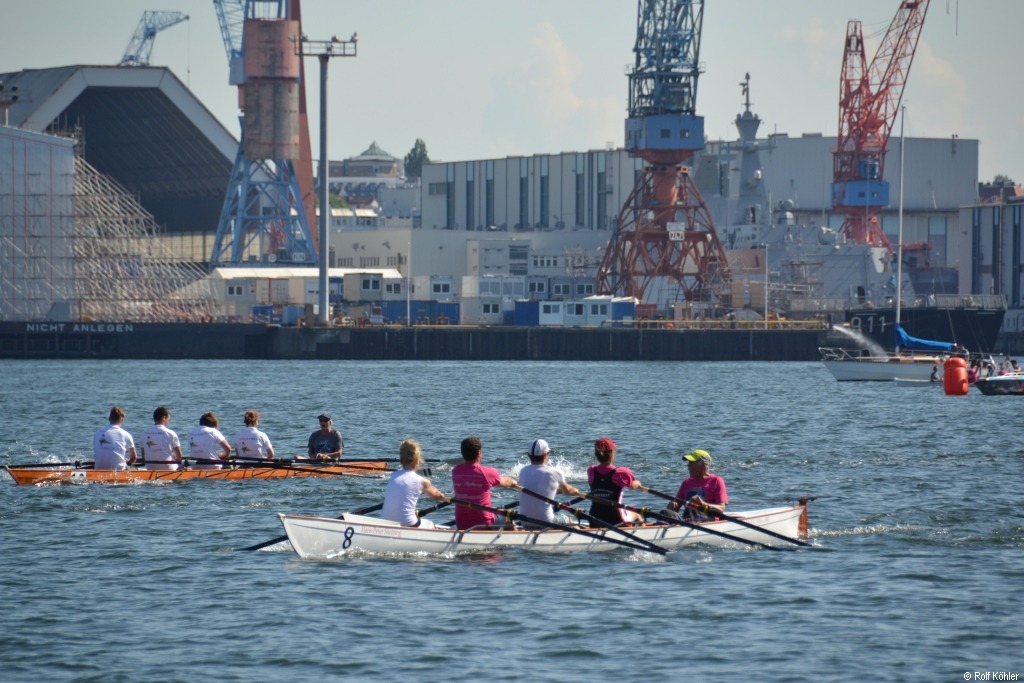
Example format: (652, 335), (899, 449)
(0, 361), (1024, 683)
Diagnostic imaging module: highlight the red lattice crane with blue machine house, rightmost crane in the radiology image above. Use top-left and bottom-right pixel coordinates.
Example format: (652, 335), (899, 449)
(833, 0), (929, 251)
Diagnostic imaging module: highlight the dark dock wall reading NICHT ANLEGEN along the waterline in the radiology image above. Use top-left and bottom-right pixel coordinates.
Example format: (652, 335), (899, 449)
(0, 323), (825, 360)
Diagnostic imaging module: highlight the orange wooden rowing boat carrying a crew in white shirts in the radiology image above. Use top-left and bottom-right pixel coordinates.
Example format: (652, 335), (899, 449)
(4, 460), (389, 485)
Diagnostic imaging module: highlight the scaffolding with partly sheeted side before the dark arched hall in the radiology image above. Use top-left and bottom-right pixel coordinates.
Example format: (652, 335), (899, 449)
(0, 127), (219, 323)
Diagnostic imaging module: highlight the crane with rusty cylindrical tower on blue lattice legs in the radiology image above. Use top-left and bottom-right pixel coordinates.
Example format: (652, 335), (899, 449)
(210, 0), (319, 267)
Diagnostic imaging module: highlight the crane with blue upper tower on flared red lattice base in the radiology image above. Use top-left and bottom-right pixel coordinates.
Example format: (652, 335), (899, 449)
(597, 0), (728, 302)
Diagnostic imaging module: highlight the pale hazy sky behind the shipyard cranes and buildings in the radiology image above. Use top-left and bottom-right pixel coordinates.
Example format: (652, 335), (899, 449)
(0, 0), (1024, 182)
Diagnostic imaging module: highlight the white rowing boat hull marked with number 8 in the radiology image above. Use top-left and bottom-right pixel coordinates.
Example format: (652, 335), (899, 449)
(279, 505), (807, 558)
